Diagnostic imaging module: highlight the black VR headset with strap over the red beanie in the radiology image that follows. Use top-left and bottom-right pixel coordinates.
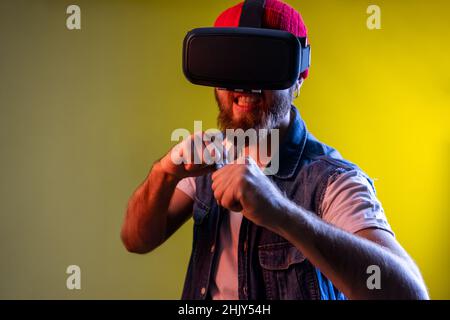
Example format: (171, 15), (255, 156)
(183, 0), (311, 92)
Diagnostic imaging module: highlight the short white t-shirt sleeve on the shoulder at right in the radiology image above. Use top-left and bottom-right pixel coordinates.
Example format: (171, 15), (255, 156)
(320, 170), (394, 235)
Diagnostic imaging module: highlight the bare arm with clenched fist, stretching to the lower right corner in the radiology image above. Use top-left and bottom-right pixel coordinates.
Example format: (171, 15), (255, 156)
(212, 159), (428, 299)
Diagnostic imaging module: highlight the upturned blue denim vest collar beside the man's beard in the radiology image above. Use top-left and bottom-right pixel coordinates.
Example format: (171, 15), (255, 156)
(274, 105), (307, 179)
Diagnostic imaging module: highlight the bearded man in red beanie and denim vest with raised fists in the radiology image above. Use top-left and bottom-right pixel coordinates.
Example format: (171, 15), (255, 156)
(122, 0), (428, 299)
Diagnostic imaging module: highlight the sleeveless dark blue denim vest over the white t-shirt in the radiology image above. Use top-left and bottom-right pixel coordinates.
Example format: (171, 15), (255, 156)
(182, 106), (372, 300)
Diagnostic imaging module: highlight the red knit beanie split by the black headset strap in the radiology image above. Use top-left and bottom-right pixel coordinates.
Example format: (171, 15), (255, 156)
(214, 0), (309, 79)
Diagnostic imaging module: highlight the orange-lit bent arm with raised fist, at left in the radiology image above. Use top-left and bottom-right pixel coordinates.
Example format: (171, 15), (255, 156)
(121, 133), (214, 253)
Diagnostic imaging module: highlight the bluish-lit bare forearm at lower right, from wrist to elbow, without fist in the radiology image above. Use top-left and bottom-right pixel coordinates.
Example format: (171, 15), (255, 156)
(273, 200), (428, 299)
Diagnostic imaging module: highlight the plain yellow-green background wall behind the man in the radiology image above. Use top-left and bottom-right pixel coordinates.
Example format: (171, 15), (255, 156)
(0, 0), (450, 299)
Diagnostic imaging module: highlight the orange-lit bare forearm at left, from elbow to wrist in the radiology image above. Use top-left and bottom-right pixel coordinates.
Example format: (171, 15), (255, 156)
(121, 162), (179, 253)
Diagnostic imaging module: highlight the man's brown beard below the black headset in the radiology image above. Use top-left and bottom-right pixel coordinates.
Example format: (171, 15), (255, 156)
(214, 88), (294, 131)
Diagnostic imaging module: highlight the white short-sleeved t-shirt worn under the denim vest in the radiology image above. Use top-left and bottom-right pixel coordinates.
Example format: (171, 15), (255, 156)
(177, 170), (392, 300)
